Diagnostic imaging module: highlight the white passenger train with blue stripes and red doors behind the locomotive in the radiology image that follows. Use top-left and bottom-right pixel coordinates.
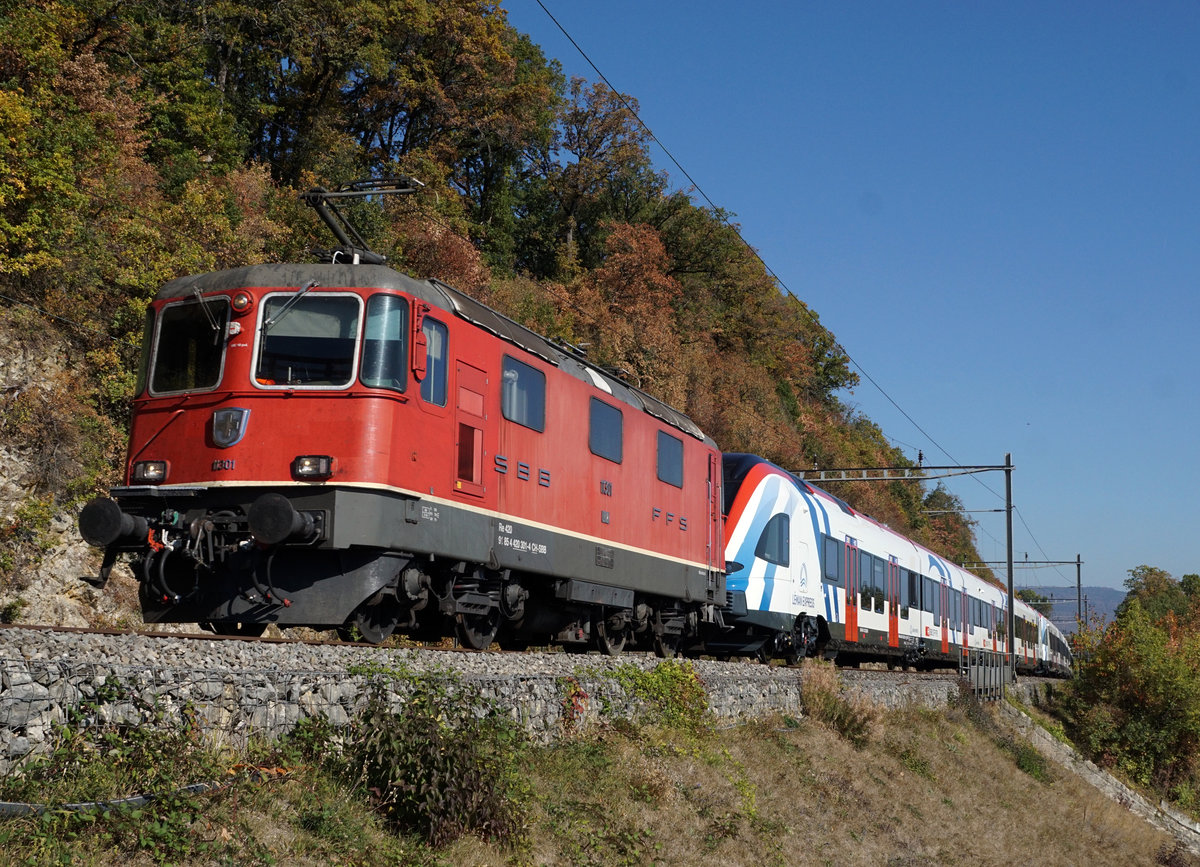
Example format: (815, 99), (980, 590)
(724, 454), (1070, 674)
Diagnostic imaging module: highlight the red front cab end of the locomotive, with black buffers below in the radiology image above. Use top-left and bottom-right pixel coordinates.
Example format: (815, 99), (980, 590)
(79, 265), (446, 630)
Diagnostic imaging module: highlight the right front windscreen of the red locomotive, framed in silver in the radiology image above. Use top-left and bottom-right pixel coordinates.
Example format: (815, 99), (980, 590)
(254, 293), (360, 388)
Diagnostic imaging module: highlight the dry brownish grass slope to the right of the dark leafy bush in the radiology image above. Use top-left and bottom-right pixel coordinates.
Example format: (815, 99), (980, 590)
(443, 711), (1200, 867)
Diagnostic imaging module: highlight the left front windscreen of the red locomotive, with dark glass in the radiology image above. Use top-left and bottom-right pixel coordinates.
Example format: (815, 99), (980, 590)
(150, 298), (229, 394)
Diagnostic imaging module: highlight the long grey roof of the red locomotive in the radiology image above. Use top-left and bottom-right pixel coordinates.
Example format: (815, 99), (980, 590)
(155, 263), (715, 447)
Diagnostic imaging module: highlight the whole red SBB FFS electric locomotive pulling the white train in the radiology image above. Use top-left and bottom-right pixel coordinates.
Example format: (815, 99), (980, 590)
(80, 265), (724, 641)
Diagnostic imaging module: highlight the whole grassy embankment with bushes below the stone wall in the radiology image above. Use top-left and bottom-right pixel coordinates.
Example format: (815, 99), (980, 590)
(0, 664), (1194, 867)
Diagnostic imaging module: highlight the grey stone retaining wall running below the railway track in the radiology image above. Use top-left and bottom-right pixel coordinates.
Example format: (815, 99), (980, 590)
(0, 628), (958, 773)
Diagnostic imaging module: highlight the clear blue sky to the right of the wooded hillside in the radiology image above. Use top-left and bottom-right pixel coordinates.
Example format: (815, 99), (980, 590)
(504, 0), (1200, 588)
